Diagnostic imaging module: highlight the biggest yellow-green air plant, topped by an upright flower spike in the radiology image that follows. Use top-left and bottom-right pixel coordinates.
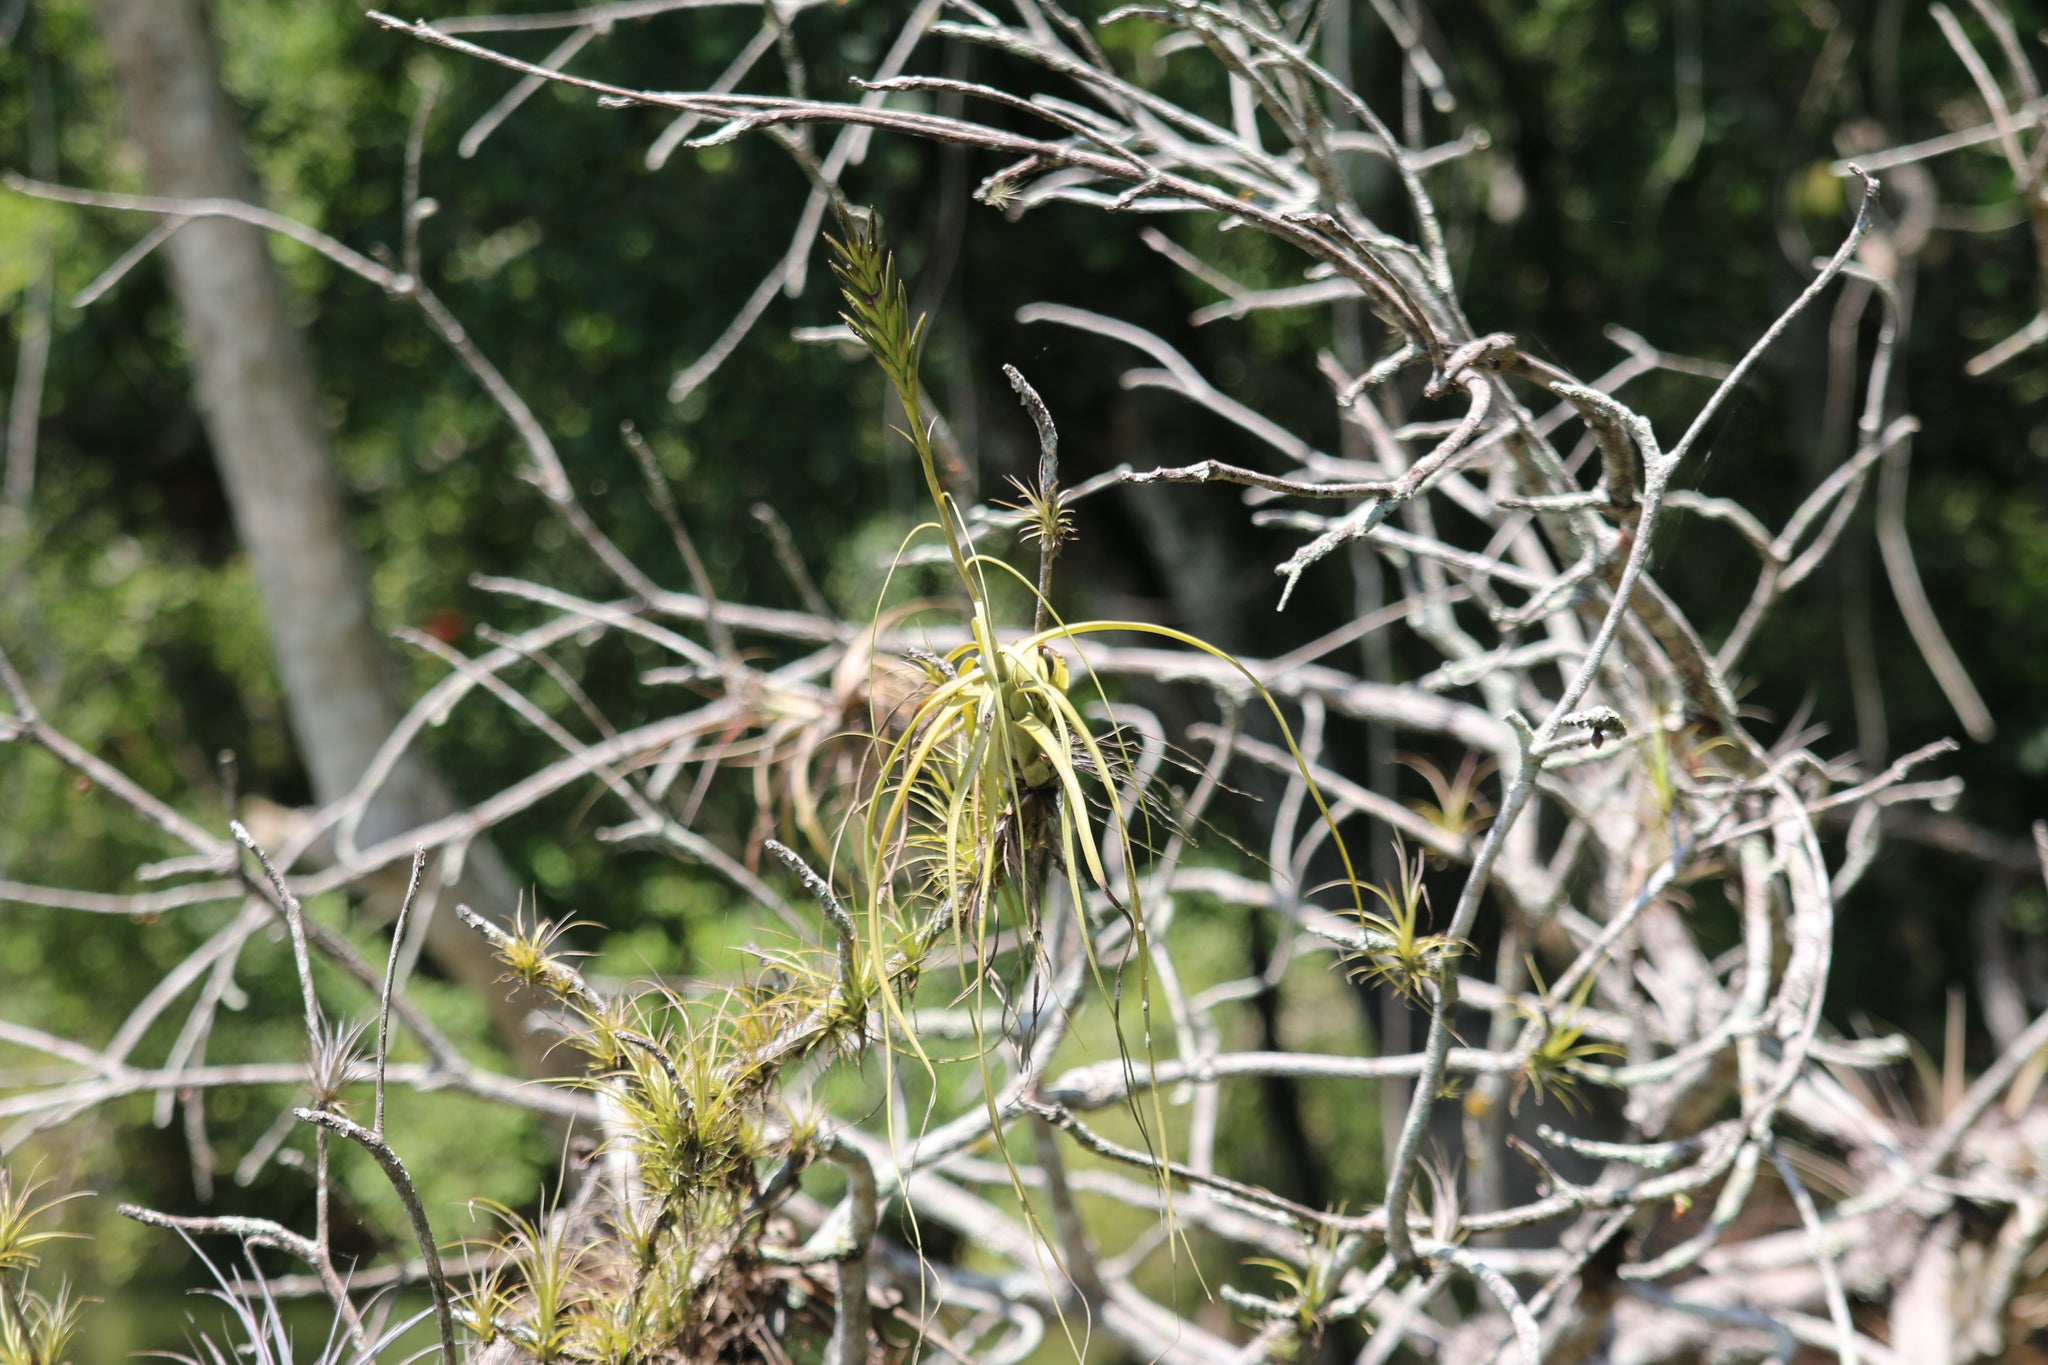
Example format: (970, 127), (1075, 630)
(831, 211), (1350, 1023)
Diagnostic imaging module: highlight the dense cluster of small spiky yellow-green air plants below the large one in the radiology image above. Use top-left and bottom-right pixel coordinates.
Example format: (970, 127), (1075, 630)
(457, 908), (868, 1365)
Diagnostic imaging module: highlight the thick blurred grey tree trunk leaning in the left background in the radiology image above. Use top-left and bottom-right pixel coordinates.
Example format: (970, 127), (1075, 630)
(98, 0), (541, 1072)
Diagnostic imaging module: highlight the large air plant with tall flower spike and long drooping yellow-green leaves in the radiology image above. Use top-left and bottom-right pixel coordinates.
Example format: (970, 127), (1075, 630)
(815, 209), (1362, 1268)
